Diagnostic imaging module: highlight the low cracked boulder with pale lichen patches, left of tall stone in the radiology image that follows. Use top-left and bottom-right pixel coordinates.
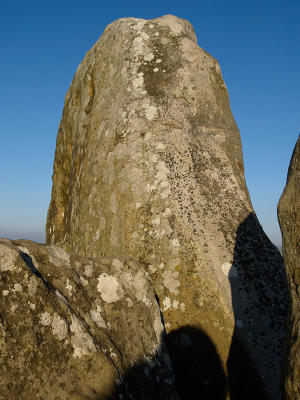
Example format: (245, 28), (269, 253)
(0, 239), (177, 400)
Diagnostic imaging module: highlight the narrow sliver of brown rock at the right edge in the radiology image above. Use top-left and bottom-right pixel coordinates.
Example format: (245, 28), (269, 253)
(278, 137), (300, 400)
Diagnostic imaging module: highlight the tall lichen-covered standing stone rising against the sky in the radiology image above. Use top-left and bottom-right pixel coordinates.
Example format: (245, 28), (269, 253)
(46, 15), (287, 398)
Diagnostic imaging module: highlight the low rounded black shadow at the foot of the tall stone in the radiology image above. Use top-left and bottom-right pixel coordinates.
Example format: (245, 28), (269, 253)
(110, 326), (226, 400)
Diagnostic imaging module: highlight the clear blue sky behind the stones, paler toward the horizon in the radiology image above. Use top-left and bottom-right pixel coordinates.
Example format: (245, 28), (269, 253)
(0, 0), (300, 244)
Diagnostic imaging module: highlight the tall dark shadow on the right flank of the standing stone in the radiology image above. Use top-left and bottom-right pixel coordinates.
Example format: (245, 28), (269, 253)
(227, 213), (288, 400)
